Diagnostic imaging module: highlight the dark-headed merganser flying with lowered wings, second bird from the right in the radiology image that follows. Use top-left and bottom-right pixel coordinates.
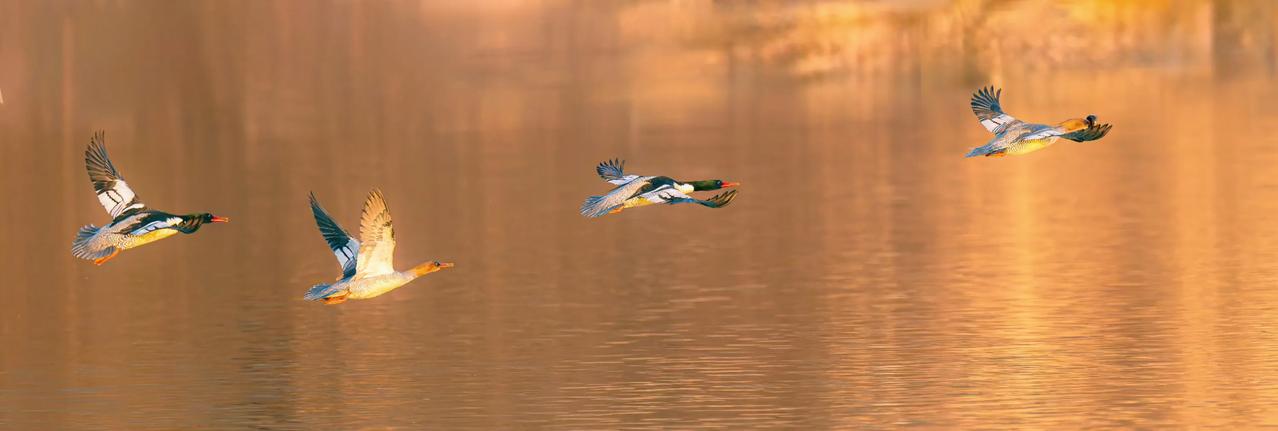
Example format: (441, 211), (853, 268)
(581, 160), (740, 217)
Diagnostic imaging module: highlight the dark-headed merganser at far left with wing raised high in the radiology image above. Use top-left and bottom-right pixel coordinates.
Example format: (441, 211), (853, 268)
(72, 132), (230, 265)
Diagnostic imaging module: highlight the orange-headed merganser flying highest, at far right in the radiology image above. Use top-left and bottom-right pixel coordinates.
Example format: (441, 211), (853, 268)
(967, 87), (1111, 157)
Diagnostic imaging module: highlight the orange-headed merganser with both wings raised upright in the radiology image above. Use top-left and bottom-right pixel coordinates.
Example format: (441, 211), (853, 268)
(303, 188), (452, 304)
